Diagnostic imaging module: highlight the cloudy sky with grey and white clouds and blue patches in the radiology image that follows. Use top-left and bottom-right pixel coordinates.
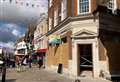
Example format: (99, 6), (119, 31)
(0, 0), (48, 47)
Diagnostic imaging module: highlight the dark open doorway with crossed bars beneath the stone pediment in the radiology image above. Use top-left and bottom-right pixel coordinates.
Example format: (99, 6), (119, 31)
(78, 44), (93, 77)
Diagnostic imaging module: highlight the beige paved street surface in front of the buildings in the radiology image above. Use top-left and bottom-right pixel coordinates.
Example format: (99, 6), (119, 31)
(0, 68), (109, 82)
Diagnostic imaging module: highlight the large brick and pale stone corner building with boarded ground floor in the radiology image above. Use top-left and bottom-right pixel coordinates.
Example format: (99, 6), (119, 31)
(46, 0), (120, 78)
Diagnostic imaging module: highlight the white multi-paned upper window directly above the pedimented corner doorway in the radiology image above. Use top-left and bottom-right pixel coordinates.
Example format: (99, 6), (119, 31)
(78, 0), (90, 14)
